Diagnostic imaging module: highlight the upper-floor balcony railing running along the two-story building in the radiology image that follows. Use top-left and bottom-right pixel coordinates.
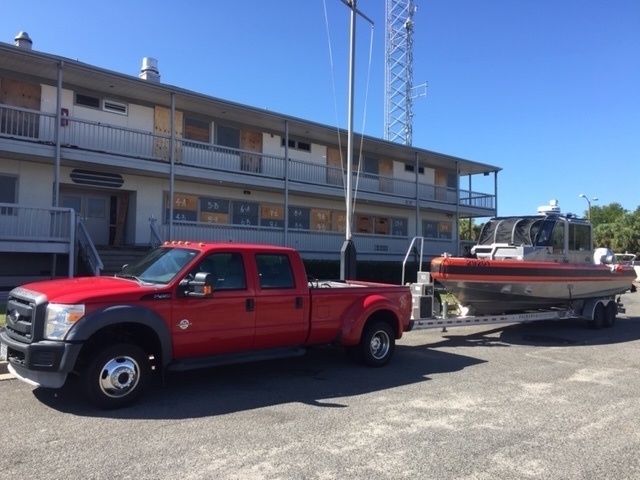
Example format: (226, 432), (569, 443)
(0, 105), (495, 210)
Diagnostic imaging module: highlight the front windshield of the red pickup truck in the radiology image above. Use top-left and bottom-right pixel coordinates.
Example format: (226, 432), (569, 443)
(116, 247), (198, 284)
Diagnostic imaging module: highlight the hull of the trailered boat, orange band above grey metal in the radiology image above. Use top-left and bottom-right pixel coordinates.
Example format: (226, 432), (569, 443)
(431, 257), (636, 315)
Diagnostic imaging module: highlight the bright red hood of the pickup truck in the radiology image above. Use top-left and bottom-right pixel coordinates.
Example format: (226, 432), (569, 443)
(14, 277), (170, 304)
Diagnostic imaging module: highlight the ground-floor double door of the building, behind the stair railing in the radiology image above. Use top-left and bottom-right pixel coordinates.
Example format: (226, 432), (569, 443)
(61, 192), (111, 245)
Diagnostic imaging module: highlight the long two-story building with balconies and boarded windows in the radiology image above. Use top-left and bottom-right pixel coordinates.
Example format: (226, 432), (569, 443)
(0, 32), (500, 286)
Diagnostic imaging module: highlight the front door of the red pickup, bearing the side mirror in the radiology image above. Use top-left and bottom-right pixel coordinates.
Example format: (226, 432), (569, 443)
(172, 251), (256, 358)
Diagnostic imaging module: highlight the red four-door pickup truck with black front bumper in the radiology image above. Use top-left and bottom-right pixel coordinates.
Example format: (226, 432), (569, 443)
(0, 242), (411, 408)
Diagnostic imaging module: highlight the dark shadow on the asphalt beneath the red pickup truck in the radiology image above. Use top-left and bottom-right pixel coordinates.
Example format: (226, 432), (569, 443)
(33, 345), (484, 419)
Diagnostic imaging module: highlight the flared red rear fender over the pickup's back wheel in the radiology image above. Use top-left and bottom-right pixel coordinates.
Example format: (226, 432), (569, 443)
(339, 295), (403, 345)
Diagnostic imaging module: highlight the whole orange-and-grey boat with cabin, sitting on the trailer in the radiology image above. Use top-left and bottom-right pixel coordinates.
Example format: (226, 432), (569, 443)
(431, 203), (637, 314)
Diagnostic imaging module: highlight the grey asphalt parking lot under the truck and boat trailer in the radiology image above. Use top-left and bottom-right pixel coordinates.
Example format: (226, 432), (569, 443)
(0, 293), (640, 480)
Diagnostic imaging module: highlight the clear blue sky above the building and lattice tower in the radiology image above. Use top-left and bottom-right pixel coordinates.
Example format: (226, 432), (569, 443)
(0, 0), (640, 215)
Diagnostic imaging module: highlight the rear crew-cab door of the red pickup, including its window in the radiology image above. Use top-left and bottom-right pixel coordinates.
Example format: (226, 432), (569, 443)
(254, 252), (310, 349)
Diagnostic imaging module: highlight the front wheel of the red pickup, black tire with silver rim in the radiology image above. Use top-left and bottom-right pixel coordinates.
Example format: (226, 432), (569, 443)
(80, 343), (151, 410)
